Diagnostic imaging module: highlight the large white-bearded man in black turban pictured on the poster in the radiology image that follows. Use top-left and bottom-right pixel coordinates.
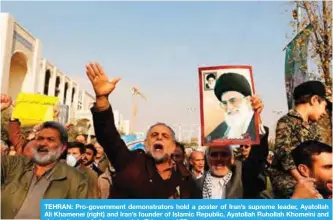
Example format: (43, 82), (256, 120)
(206, 73), (262, 142)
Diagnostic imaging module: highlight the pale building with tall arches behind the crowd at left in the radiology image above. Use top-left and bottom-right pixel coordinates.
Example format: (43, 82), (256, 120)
(0, 13), (95, 134)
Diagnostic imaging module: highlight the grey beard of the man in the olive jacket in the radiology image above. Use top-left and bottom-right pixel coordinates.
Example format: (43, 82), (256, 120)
(31, 146), (62, 165)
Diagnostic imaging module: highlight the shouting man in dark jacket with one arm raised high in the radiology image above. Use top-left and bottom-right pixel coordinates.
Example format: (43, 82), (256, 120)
(86, 63), (201, 199)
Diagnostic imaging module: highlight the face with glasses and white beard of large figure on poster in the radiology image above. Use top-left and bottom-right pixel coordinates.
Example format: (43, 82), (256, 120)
(221, 91), (252, 126)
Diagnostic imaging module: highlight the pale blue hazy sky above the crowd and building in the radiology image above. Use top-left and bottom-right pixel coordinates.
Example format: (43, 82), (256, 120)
(2, 2), (291, 139)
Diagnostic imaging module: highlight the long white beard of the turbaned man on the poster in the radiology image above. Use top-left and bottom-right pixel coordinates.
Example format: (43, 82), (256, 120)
(225, 101), (253, 138)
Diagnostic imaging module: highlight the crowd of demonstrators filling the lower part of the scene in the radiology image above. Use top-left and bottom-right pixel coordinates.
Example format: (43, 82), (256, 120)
(1, 60), (332, 218)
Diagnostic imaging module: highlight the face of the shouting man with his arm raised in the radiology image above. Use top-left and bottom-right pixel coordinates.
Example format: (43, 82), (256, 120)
(145, 125), (176, 163)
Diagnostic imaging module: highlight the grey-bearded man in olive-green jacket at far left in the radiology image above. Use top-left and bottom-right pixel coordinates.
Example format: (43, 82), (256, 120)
(1, 118), (88, 219)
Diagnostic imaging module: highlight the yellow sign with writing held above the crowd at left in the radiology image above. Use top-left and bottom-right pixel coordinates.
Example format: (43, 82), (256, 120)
(12, 93), (58, 126)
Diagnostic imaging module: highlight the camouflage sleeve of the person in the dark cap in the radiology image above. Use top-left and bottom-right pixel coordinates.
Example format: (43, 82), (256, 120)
(275, 116), (296, 171)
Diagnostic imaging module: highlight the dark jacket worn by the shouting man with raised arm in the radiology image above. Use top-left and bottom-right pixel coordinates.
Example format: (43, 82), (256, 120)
(91, 107), (201, 199)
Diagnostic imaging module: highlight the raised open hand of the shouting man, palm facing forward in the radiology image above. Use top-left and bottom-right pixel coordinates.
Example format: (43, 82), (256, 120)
(86, 63), (120, 97)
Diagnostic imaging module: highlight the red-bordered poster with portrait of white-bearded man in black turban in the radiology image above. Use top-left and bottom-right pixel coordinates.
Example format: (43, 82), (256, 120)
(199, 66), (260, 146)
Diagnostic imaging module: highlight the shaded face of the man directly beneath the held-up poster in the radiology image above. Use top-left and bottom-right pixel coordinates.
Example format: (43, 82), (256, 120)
(208, 146), (232, 177)
